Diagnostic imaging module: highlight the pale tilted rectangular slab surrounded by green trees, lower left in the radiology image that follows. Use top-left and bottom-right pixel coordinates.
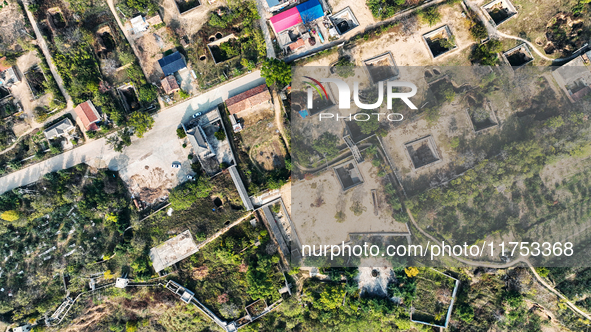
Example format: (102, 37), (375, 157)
(149, 230), (199, 273)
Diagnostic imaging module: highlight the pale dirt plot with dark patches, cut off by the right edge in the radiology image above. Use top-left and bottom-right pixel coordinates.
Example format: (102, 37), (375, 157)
(552, 51), (591, 103)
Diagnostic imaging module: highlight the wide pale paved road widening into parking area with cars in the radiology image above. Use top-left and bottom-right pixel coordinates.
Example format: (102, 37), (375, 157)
(0, 71), (264, 193)
